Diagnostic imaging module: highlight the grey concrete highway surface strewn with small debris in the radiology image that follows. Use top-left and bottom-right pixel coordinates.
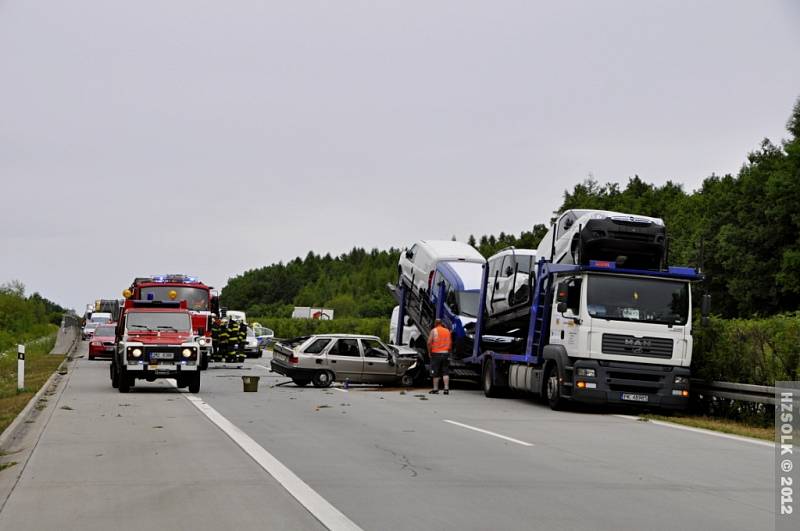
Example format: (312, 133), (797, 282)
(0, 344), (774, 531)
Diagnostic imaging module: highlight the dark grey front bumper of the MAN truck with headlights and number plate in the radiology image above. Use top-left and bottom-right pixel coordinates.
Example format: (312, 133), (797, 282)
(569, 360), (690, 409)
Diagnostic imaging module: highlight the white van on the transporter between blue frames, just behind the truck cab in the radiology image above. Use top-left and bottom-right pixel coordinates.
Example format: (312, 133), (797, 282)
(486, 247), (536, 315)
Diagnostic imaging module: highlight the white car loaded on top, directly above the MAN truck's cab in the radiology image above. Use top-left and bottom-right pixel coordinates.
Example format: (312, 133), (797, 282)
(536, 210), (666, 269)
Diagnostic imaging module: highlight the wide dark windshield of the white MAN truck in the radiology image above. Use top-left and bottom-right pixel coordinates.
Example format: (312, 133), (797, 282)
(586, 275), (689, 325)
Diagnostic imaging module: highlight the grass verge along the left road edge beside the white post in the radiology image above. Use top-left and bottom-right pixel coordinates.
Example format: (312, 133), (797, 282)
(0, 335), (64, 433)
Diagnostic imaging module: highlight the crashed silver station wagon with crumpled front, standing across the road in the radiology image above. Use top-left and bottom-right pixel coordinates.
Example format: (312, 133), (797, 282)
(271, 334), (425, 387)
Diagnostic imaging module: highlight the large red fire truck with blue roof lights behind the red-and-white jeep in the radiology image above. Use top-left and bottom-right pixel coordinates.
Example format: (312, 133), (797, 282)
(122, 274), (219, 370)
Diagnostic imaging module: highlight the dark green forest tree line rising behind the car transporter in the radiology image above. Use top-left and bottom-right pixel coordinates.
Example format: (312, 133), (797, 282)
(221, 96), (800, 318)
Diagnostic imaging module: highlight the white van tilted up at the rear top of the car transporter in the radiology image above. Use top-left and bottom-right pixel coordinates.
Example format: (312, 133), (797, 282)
(397, 240), (486, 293)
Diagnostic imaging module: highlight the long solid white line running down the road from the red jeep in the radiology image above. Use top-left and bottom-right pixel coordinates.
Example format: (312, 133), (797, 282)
(171, 380), (363, 531)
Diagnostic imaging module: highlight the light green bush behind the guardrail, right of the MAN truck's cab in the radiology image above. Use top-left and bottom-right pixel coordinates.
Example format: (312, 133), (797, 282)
(692, 312), (800, 385)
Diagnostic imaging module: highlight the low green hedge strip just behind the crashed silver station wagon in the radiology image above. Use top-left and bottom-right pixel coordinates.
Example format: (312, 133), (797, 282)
(247, 315), (389, 340)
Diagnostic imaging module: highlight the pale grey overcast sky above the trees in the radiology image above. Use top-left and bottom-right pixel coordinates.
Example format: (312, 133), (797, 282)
(0, 0), (800, 310)
